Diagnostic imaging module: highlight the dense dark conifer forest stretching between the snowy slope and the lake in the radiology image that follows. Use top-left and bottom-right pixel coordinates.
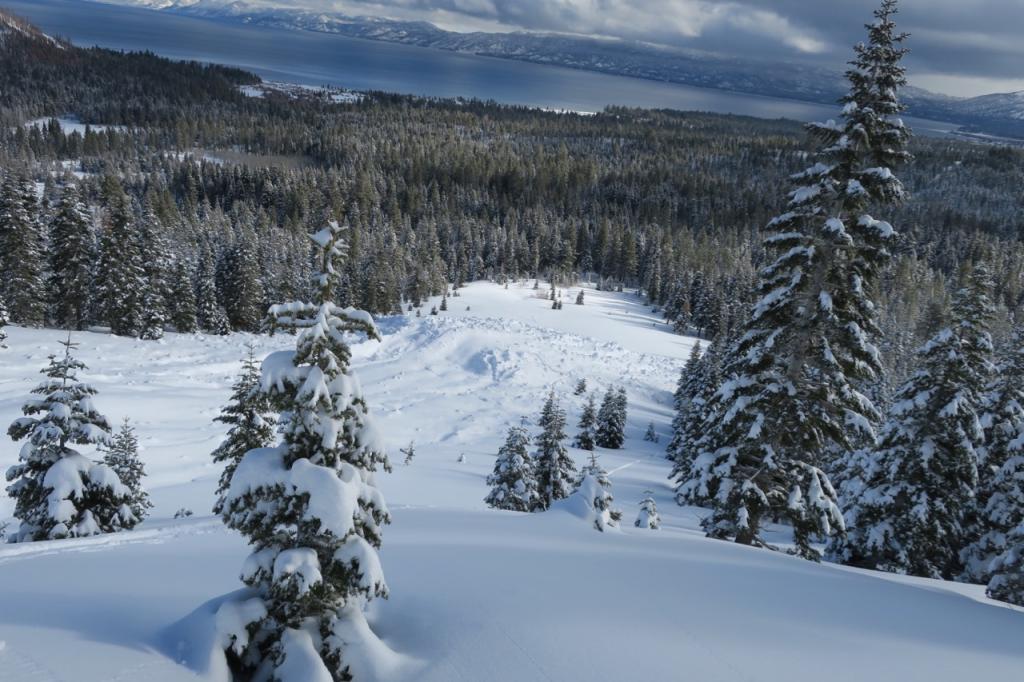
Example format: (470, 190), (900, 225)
(0, 7), (1024, 401)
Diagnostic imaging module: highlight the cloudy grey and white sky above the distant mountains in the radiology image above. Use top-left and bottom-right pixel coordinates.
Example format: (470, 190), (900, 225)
(263, 0), (1024, 95)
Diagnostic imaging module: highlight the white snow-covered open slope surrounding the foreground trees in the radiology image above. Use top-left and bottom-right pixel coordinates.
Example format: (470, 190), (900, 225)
(0, 282), (1024, 682)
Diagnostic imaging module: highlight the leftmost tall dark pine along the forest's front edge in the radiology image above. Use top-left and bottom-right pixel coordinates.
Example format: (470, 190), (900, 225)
(0, 173), (46, 327)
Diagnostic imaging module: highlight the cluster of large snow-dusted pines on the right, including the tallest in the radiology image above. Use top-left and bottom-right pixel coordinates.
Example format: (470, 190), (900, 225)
(668, 0), (1024, 603)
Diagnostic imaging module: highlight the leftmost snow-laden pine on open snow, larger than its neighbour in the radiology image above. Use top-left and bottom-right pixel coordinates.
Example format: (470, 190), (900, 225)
(7, 337), (138, 542)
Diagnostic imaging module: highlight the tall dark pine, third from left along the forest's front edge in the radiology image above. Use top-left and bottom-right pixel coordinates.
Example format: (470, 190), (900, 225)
(97, 178), (146, 336)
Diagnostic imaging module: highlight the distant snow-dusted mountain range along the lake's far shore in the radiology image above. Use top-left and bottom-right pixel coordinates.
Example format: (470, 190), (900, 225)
(93, 0), (1024, 138)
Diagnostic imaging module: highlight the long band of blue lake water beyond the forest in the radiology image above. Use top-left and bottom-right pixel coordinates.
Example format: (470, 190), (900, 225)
(6, 0), (956, 134)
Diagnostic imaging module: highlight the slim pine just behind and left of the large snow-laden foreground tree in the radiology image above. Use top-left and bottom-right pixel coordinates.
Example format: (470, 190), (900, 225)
(211, 343), (276, 514)
